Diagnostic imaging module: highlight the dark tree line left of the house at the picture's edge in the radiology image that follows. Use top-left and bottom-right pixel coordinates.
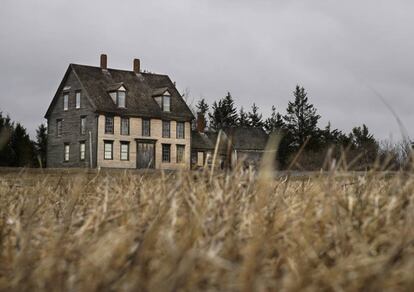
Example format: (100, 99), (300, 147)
(0, 112), (47, 167)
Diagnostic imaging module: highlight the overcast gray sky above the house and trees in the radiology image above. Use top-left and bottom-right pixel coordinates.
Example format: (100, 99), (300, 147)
(0, 0), (414, 140)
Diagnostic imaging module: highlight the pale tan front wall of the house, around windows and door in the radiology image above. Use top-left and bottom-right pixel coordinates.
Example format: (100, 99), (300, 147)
(97, 115), (191, 169)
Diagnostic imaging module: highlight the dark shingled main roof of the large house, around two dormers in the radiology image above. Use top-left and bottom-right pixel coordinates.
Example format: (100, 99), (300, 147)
(45, 64), (194, 121)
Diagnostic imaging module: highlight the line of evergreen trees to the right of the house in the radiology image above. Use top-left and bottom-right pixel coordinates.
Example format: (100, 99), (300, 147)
(196, 85), (392, 170)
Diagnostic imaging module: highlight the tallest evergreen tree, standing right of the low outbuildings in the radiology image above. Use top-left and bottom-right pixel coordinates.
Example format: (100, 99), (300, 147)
(283, 85), (320, 150)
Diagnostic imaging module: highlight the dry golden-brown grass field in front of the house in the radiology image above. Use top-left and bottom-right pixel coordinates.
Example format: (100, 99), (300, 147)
(0, 164), (414, 291)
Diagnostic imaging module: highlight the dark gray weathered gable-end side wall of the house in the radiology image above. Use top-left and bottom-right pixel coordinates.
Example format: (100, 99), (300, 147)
(47, 72), (97, 167)
